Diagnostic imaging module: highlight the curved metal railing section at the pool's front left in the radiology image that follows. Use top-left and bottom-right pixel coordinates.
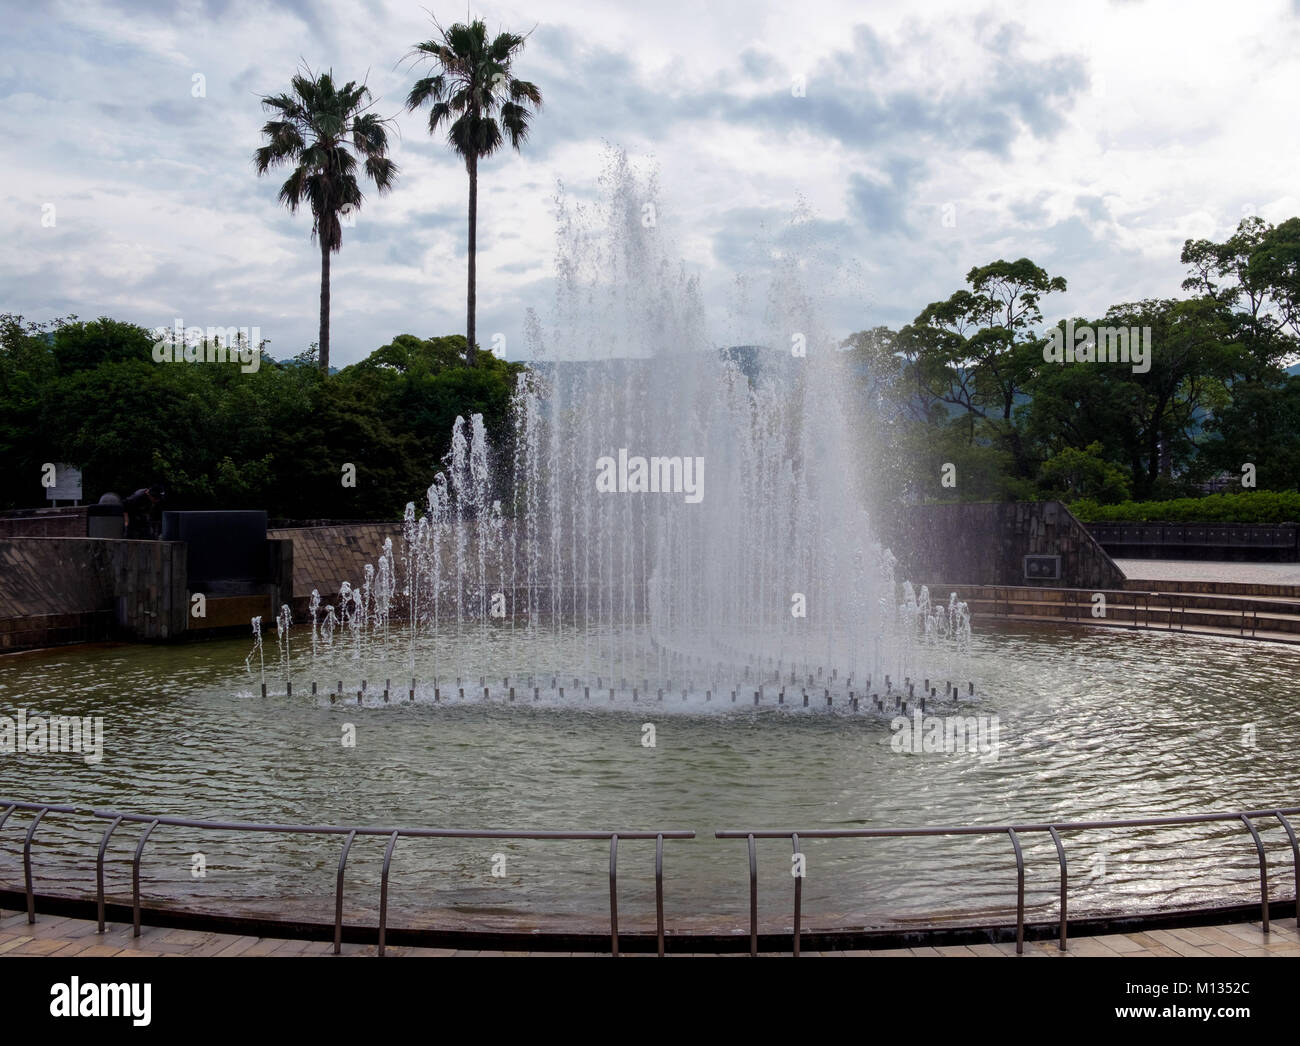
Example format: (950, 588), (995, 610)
(0, 799), (696, 956)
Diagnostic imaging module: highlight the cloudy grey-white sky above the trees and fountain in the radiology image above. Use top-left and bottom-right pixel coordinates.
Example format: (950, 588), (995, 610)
(0, 0), (1300, 364)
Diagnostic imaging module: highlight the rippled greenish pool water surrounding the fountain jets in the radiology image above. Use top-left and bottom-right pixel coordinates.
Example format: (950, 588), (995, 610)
(0, 629), (1300, 929)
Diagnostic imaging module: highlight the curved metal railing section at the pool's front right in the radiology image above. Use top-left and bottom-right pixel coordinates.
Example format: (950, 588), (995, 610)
(714, 807), (1300, 955)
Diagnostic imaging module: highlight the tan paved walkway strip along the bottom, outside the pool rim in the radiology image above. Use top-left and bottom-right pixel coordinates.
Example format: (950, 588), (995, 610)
(0, 912), (1300, 958)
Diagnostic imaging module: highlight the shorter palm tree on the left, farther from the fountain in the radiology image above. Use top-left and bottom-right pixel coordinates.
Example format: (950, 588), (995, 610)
(254, 69), (398, 374)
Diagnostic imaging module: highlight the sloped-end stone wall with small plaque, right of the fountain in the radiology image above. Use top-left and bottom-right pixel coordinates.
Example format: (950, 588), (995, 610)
(883, 502), (1125, 589)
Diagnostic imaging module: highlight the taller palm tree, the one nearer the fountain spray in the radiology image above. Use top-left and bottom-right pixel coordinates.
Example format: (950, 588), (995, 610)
(407, 18), (542, 366)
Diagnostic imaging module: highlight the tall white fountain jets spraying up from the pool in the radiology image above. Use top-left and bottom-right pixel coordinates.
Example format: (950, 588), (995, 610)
(250, 155), (970, 709)
